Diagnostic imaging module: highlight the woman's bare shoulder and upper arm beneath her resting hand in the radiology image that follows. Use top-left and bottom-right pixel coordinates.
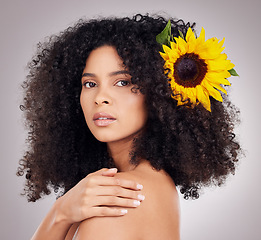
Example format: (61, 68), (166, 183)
(74, 162), (179, 240)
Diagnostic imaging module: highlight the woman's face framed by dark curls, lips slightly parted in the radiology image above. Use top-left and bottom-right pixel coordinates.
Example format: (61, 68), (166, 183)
(80, 46), (147, 142)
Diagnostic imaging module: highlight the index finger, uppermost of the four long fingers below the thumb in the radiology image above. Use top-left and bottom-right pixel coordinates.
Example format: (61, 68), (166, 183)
(88, 176), (143, 190)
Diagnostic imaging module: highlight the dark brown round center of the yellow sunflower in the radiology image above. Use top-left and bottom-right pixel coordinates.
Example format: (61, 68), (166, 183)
(174, 53), (207, 87)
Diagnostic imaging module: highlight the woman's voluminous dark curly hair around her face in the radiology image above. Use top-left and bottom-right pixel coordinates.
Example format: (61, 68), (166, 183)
(17, 14), (240, 201)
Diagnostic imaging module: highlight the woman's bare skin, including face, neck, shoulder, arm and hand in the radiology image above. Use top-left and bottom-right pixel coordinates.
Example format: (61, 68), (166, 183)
(29, 46), (179, 240)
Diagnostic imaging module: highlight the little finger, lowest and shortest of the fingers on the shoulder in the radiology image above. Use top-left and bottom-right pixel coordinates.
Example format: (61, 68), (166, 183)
(91, 207), (128, 217)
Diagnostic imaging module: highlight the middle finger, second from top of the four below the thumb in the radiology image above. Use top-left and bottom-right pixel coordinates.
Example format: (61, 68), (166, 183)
(95, 186), (145, 200)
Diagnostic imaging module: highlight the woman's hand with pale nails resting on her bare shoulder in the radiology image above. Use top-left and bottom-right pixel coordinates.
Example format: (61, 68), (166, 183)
(57, 168), (144, 224)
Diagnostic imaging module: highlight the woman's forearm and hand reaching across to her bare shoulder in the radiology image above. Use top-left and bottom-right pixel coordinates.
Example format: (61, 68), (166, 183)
(32, 169), (144, 240)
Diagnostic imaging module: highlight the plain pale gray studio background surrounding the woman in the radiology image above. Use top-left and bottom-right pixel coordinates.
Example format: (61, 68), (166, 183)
(0, 0), (261, 240)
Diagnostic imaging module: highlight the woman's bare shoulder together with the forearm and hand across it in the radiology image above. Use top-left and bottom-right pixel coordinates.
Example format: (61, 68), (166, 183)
(29, 169), (179, 240)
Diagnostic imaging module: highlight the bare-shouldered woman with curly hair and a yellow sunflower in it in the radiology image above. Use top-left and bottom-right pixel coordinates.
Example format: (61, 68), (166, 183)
(18, 15), (239, 240)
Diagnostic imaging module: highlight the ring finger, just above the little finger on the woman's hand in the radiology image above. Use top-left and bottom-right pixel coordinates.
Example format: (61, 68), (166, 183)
(90, 196), (141, 208)
